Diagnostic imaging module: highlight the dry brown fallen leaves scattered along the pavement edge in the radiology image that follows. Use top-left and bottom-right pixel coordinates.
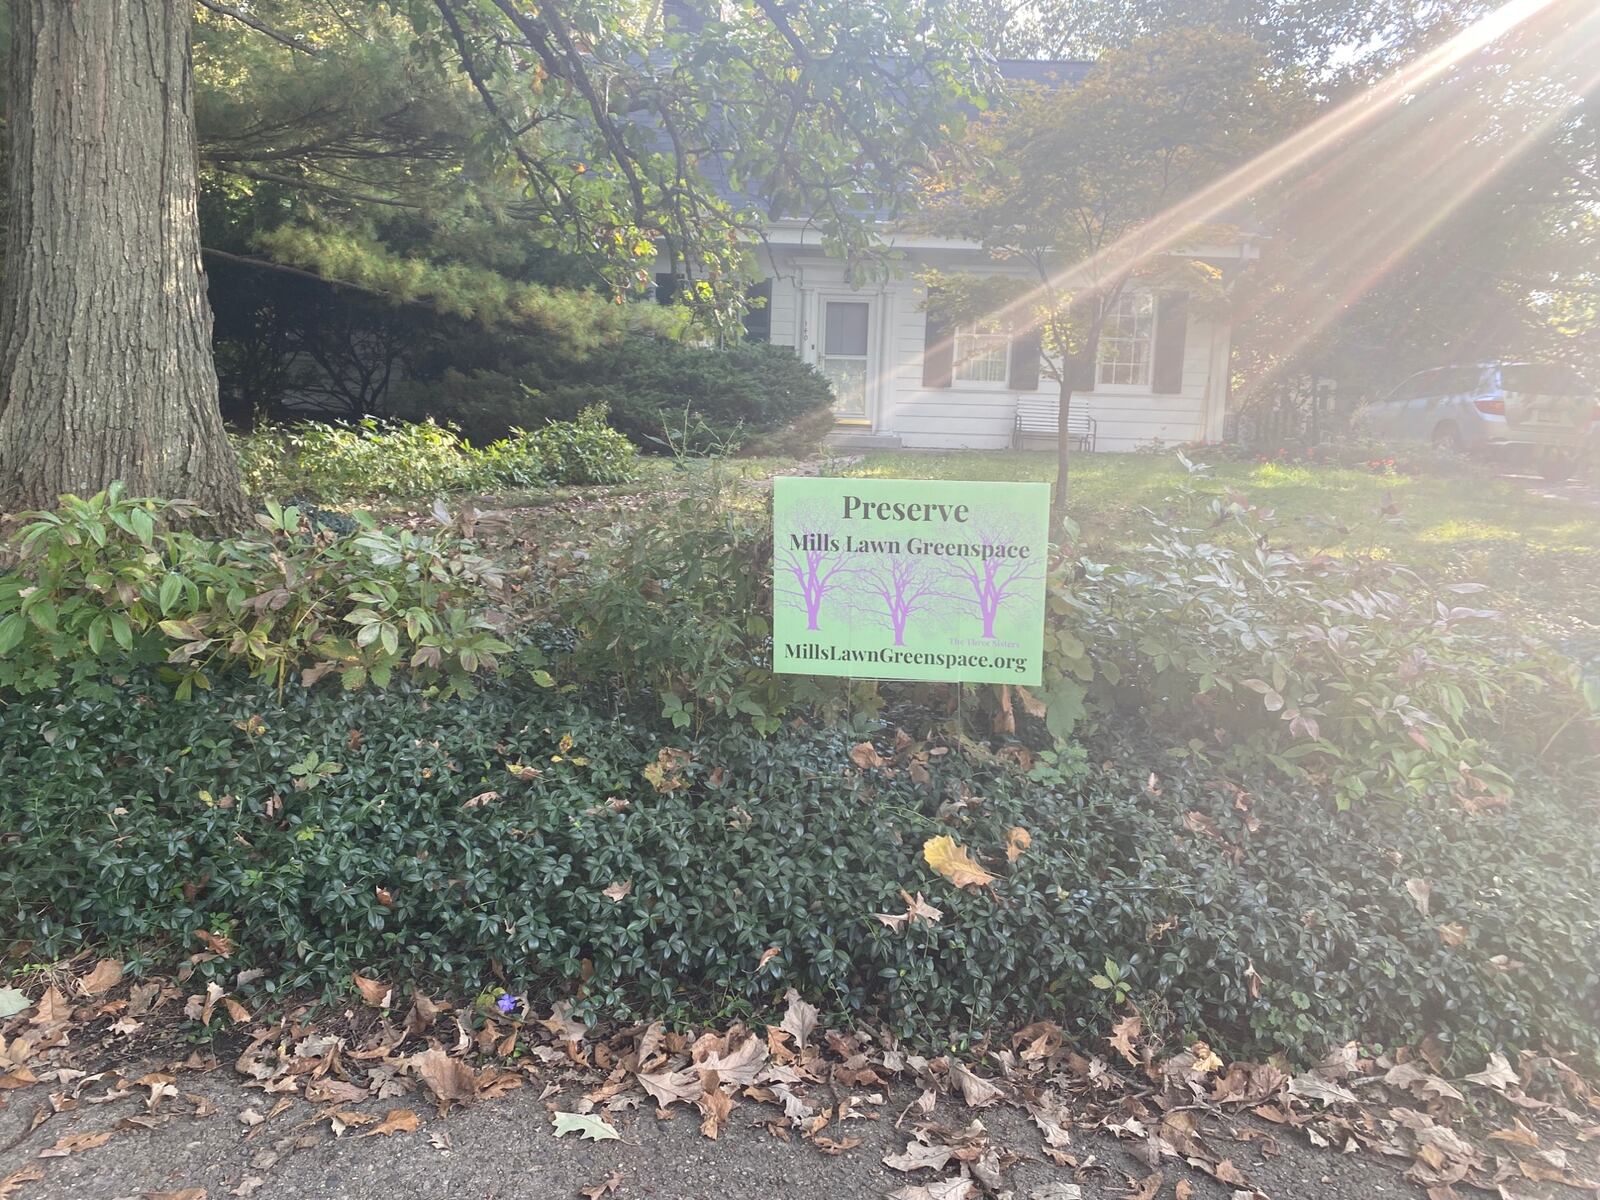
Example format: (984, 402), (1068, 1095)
(0, 960), (1600, 1200)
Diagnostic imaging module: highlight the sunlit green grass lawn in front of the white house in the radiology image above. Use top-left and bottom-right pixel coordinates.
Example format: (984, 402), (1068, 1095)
(840, 451), (1600, 640)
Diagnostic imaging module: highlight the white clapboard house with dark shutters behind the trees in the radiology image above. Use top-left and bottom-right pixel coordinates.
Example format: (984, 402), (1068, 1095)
(752, 221), (1258, 450)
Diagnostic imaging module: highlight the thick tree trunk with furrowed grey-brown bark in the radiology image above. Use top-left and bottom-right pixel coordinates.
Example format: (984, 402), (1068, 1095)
(0, 0), (243, 517)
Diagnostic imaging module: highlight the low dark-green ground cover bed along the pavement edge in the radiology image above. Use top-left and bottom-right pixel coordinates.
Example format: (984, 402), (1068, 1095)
(0, 682), (1600, 1059)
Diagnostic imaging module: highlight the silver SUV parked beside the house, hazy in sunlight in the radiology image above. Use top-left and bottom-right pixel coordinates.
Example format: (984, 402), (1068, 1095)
(1357, 363), (1600, 474)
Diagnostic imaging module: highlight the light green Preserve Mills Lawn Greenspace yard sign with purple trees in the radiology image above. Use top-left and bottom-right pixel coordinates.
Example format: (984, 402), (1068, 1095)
(773, 477), (1050, 683)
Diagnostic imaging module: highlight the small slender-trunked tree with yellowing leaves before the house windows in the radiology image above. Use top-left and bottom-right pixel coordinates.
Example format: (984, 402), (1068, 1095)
(925, 29), (1301, 510)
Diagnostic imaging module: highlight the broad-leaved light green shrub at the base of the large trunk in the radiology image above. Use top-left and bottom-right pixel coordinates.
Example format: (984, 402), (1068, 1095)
(0, 485), (507, 698)
